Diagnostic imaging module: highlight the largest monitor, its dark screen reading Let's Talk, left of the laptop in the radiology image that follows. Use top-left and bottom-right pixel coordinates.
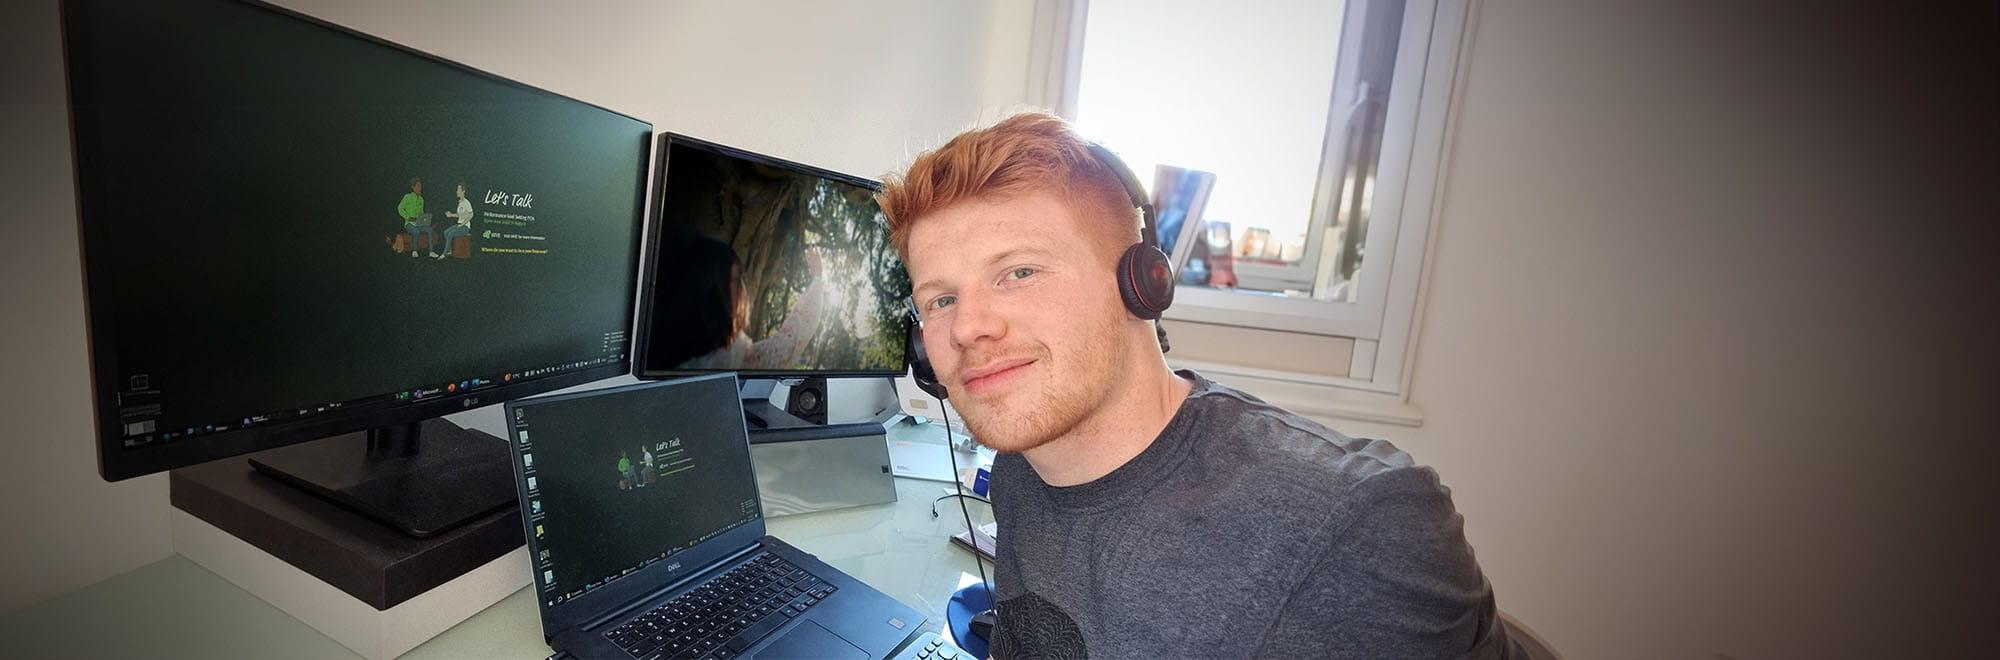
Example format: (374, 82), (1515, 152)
(64, 0), (652, 480)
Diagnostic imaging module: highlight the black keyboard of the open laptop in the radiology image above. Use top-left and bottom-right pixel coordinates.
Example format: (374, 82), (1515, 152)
(604, 552), (834, 660)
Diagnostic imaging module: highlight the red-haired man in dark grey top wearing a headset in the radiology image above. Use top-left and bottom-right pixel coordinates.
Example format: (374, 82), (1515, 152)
(880, 112), (1514, 658)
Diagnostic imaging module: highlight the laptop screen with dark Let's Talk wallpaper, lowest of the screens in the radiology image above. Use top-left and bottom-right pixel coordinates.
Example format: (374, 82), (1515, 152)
(512, 374), (760, 604)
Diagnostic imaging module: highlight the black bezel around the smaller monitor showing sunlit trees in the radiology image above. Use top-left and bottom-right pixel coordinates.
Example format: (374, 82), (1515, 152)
(632, 132), (910, 380)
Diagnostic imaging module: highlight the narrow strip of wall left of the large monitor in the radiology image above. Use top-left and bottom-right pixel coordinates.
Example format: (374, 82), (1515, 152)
(0, 2), (172, 612)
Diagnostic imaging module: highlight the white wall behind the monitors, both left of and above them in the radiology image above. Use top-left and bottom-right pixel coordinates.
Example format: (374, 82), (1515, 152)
(0, 0), (1028, 612)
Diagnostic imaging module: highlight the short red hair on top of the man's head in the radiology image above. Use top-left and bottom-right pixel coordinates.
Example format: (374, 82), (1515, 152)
(876, 112), (1140, 262)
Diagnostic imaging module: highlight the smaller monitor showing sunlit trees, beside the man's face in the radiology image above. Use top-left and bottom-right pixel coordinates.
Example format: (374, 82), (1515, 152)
(636, 134), (910, 376)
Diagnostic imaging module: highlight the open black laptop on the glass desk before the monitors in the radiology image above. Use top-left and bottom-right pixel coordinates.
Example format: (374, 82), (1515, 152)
(506, 374), (924, 660)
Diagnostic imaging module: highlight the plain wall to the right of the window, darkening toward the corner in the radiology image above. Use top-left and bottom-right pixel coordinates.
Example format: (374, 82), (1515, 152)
(1332, 0), (2000, 658)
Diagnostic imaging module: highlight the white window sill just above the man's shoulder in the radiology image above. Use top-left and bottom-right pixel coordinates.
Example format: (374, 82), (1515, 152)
(1166, 356), (1424, 428)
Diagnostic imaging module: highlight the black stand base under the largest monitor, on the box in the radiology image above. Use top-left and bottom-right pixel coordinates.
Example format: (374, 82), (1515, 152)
(250, 420), (516, 538)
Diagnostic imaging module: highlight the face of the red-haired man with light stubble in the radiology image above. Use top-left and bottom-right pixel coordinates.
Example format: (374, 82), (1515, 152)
(908, 192), (1130, 452)
